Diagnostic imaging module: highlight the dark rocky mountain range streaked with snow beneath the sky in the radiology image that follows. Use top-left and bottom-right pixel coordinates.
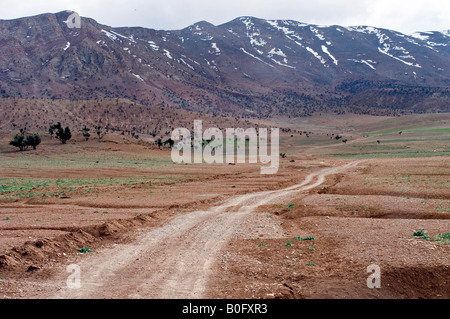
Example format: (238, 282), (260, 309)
(0, 11), (450, 118)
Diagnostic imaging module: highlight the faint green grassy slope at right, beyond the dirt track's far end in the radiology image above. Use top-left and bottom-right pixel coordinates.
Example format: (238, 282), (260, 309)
(282, 114), (450, 159)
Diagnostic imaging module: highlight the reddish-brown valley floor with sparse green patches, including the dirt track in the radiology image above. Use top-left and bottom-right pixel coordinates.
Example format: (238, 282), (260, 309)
(0, 116), (450, 299)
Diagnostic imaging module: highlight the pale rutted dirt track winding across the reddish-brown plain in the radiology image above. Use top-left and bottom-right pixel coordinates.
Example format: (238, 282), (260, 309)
(45, 161), (361, 299)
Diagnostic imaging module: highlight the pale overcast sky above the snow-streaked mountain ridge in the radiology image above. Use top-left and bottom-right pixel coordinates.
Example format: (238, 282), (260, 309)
(0, 0), (450, 34)
